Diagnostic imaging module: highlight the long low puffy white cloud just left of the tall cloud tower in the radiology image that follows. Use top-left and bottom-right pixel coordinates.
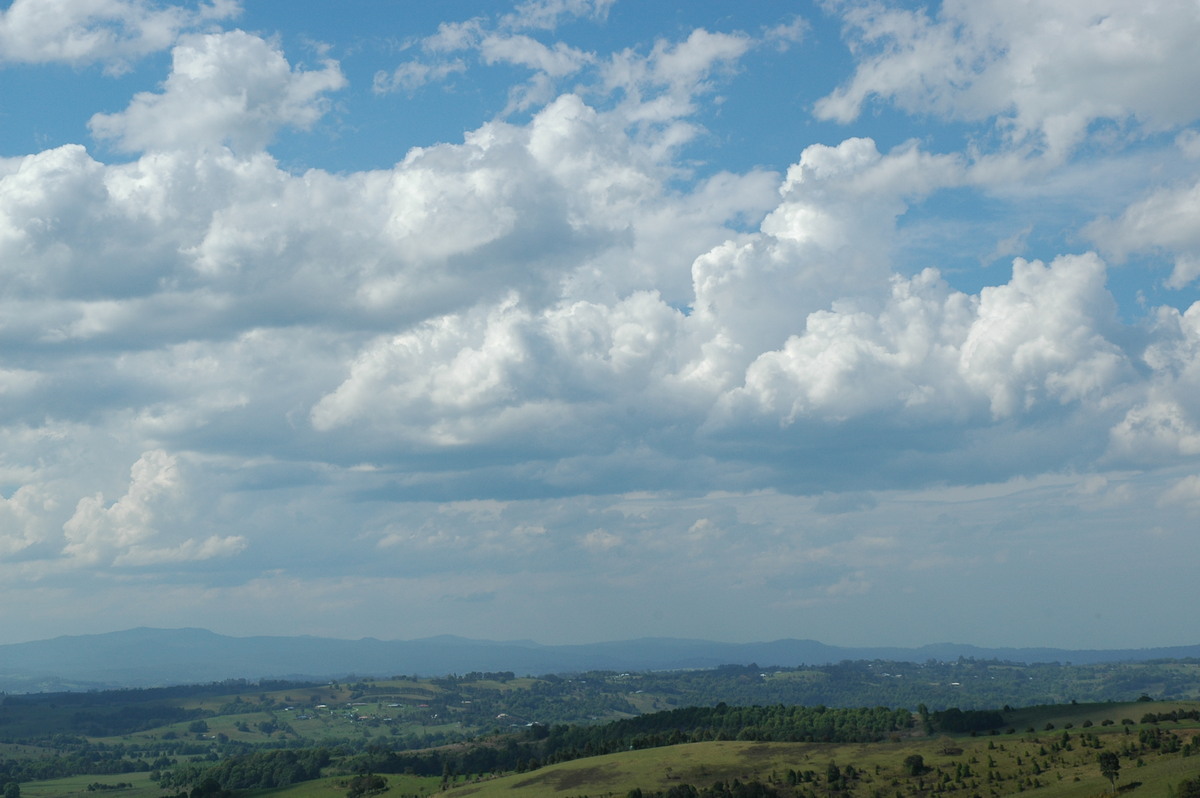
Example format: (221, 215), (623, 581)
(304, 288), (683, 449)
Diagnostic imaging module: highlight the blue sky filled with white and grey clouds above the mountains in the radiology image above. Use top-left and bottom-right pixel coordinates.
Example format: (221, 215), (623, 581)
(0, 0), (1200, 648)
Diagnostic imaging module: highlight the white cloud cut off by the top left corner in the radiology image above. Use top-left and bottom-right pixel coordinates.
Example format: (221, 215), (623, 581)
(0, 0), (241, 73)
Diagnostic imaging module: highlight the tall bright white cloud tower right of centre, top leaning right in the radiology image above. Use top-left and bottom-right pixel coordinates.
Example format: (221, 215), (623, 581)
(692, 138), (962, 367)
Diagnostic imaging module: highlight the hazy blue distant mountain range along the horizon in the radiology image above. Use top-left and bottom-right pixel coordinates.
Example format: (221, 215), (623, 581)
(0, 628), (1200, 692)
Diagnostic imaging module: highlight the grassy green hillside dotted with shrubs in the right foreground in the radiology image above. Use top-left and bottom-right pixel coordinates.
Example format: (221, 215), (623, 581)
(434, 703), (1200, 798)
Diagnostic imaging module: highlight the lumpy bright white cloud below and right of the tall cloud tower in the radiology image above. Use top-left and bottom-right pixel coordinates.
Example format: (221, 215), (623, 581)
(730, 256), (1133, 424)
